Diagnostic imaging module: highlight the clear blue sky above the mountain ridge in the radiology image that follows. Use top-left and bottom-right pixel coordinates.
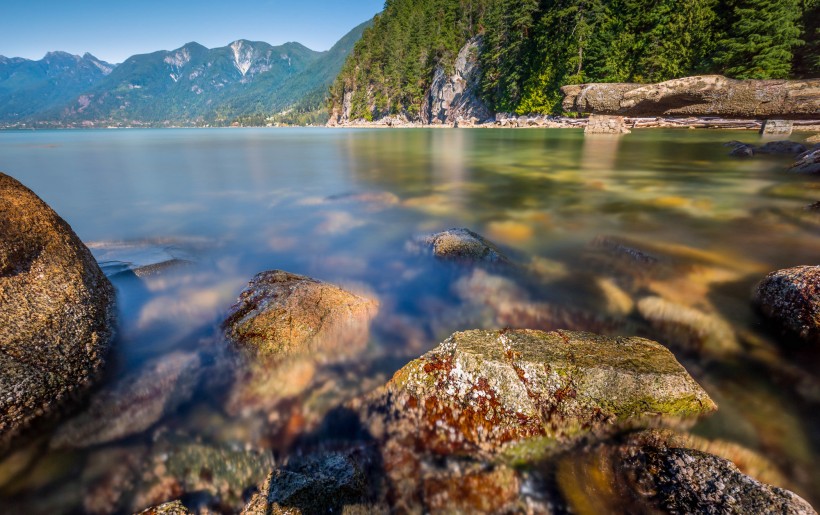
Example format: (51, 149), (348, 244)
(0, 0), (384, 63)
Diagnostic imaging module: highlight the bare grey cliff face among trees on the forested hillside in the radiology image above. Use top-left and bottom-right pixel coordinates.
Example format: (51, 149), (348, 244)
(421, 37), (491, 124)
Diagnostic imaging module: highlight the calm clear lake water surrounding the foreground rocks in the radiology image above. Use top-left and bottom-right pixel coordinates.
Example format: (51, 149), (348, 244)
(0, 128), (820, 513)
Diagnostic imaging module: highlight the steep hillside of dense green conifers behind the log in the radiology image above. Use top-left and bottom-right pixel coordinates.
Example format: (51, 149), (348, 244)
(330, 0), (820, 120)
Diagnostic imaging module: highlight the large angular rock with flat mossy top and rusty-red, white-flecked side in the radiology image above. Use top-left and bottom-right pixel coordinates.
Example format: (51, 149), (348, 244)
(365, 330), (716, 457)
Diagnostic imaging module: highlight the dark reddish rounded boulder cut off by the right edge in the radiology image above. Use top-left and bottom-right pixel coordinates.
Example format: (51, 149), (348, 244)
(753, 266), (820, 343)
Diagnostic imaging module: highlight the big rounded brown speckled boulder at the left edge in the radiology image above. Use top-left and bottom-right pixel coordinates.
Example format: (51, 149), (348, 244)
(0, 173), (115, 447)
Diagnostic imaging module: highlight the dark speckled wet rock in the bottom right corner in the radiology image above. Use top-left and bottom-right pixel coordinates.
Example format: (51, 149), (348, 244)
(558, 436), (815, 514)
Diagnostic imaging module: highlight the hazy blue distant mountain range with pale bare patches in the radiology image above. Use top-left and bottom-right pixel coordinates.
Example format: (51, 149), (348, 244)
(0, 21), (370, 126)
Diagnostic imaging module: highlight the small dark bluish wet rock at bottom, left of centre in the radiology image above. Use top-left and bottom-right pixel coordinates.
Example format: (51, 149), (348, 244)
(243, 453), (367, 514)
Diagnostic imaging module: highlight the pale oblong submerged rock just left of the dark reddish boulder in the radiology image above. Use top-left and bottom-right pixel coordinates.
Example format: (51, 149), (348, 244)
(637, 297), (741, 356)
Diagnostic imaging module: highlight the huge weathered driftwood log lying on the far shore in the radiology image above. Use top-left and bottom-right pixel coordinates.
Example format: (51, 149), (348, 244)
(561, 75), (820, 120)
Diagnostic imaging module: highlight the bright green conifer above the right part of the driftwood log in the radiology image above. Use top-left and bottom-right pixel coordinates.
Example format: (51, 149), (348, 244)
(715, 0), (802, 79)
